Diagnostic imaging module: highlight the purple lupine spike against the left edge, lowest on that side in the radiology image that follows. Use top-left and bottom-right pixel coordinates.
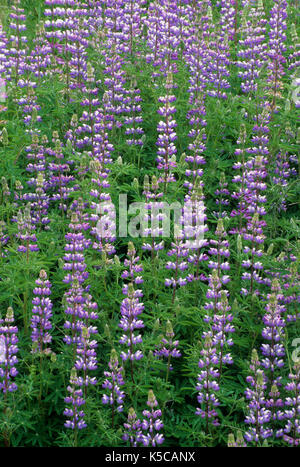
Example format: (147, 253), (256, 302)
(0, 307), (19, 397)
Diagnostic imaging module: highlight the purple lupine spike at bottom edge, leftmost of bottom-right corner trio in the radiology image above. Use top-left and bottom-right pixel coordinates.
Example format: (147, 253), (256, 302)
(245, 349), (273, 446)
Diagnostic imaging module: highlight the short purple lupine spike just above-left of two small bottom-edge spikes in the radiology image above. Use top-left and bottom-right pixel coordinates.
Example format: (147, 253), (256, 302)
(102, 349), (125, 428)
